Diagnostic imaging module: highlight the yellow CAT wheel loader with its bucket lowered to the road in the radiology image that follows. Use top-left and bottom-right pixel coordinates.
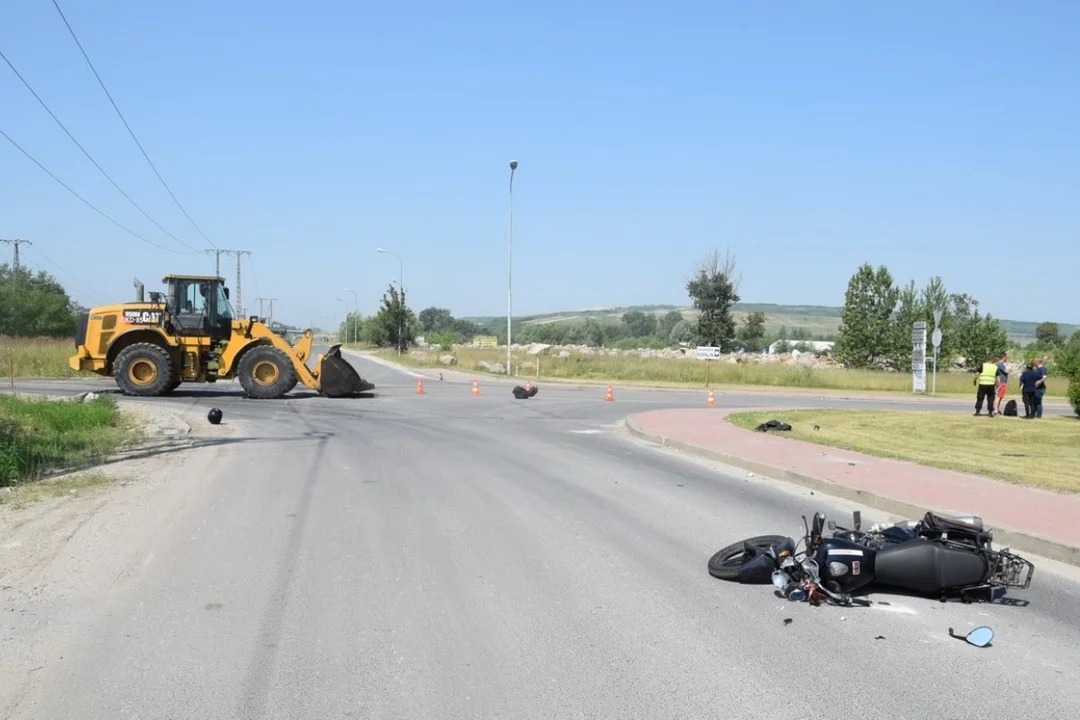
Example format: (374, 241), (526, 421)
(68, 275), (375, 399)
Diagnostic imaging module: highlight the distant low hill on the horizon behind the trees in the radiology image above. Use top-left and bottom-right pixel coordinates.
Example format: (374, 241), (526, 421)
(463, 302), (1080, 345)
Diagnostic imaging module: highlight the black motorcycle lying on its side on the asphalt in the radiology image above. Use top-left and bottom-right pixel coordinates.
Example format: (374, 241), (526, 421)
(708, 511), (1035, 606)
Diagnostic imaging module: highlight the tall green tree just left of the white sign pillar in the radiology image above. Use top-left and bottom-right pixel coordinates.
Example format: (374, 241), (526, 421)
(834, 262), (900, 368)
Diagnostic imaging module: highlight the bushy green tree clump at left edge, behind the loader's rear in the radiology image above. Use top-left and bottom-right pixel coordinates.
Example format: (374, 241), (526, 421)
(0, 264), (77, 338)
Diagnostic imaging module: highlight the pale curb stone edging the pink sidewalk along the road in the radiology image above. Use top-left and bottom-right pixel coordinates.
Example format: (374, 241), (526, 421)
(625, 416), (1080, 567)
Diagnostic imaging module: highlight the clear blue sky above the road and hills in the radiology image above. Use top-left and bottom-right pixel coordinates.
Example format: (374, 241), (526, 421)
(0, 0), (1080, 324)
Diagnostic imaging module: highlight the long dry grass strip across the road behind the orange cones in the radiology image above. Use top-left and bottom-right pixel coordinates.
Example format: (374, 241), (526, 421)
(375, 348), (1068, 404)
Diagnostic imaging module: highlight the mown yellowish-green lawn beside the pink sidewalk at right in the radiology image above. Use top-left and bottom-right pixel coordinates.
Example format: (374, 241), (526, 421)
(728, 410), (1080, 493)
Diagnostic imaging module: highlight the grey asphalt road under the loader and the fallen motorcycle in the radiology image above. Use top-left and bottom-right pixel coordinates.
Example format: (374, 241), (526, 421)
(0, 358), (1080, 720)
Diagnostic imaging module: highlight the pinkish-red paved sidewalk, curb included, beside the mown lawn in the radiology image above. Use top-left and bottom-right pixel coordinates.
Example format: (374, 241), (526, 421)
(626, 408), (1080, 566)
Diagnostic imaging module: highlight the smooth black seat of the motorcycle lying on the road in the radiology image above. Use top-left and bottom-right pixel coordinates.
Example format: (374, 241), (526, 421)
(874, 538), (989, 593)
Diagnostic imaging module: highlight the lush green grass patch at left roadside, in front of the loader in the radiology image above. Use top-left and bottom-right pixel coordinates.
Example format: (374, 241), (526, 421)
(0, 395), (135, 487)
